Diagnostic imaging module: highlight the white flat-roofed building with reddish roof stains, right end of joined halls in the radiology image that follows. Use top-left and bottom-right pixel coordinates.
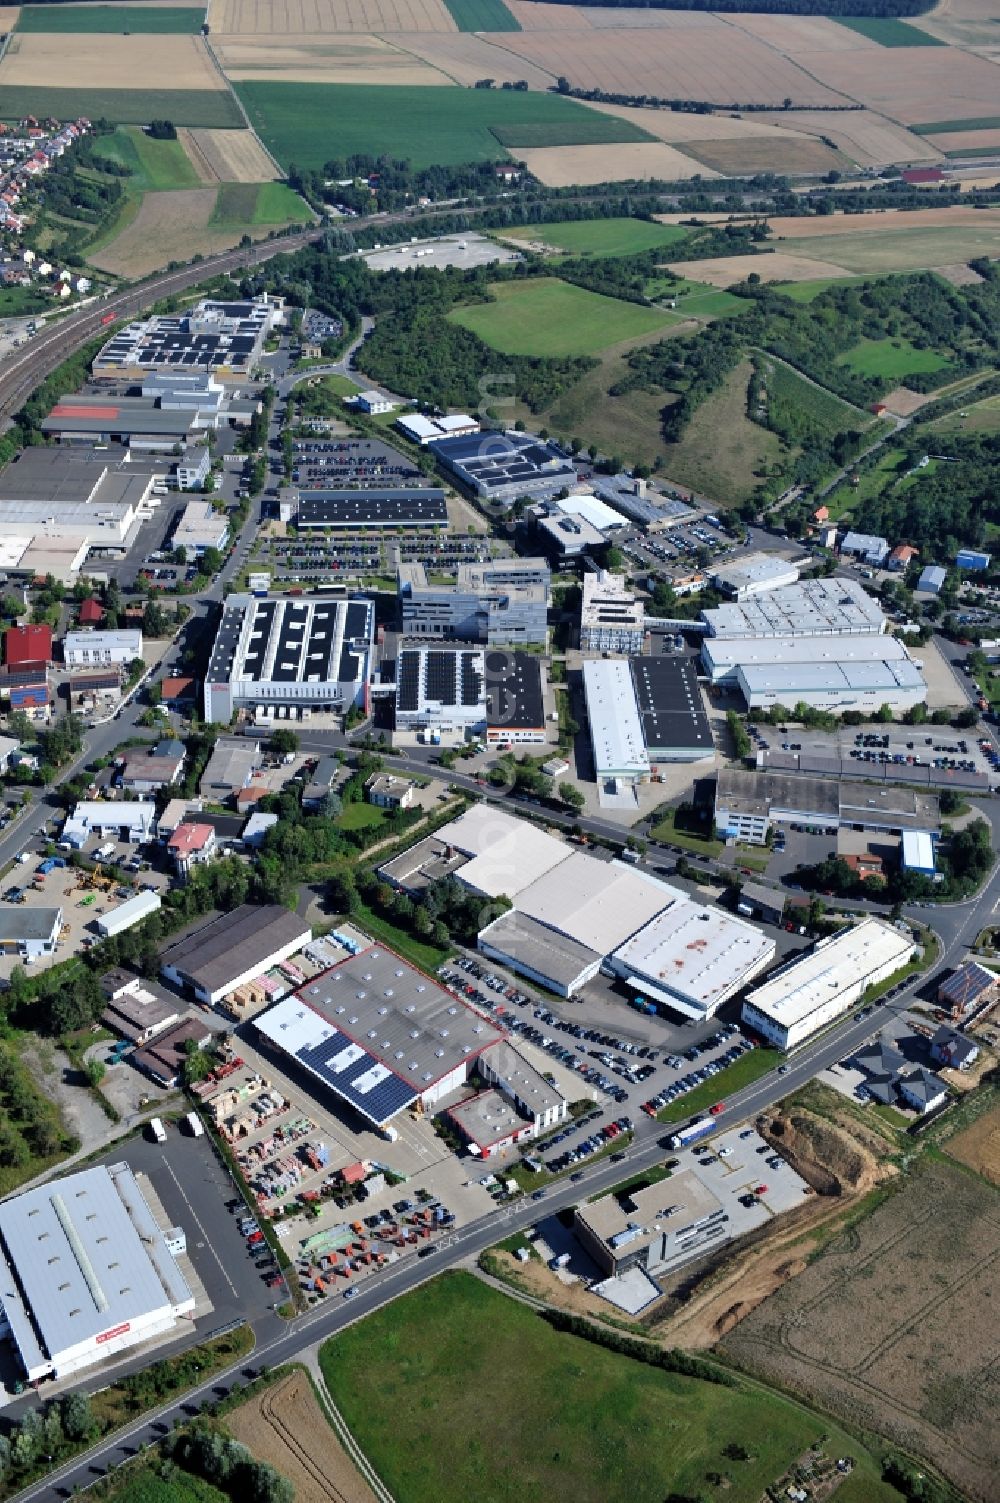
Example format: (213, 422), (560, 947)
(608, 890), (776, 1021)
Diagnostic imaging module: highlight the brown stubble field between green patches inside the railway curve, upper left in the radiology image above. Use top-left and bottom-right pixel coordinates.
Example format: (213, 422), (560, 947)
(90, 188), (284, 277)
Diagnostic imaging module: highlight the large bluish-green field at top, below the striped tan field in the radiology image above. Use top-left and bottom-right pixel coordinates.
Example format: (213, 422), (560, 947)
(234, 81), (642, 168)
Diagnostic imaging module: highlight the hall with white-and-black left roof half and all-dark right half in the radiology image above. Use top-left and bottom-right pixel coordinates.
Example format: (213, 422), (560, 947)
(394, 646), (546, 745)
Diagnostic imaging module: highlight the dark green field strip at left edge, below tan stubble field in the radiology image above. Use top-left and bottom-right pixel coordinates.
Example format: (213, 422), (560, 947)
(0, 84), (240, 131)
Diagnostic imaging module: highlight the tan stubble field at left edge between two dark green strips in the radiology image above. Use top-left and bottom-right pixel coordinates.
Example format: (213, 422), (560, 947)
(0, 32), (227, 93)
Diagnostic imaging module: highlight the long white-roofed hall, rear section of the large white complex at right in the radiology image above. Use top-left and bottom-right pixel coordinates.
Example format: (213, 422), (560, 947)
(701, 579), (886, 637)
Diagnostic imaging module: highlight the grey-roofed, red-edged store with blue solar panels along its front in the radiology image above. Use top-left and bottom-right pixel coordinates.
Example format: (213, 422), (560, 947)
(254, 945), (504, 1130)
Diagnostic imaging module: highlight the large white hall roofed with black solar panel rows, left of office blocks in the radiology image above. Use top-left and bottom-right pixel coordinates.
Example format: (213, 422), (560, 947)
(203, 595), (374, 724)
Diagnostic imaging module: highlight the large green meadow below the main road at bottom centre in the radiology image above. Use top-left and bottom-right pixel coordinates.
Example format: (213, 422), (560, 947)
(320, 1273), (898, 1503)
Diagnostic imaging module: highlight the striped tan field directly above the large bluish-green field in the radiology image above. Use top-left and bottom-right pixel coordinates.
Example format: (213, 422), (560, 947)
(212, 32), (445, 86)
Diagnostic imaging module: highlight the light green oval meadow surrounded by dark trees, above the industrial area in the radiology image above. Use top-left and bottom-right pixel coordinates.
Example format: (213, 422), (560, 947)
(448, 277), (677, 356)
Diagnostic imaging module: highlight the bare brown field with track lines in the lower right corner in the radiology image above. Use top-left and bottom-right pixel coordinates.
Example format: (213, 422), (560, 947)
(722, 1160), (1000, 1503)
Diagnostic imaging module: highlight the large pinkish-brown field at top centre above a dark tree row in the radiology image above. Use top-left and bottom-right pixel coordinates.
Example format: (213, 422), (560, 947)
(504, 17), (848, 108)
